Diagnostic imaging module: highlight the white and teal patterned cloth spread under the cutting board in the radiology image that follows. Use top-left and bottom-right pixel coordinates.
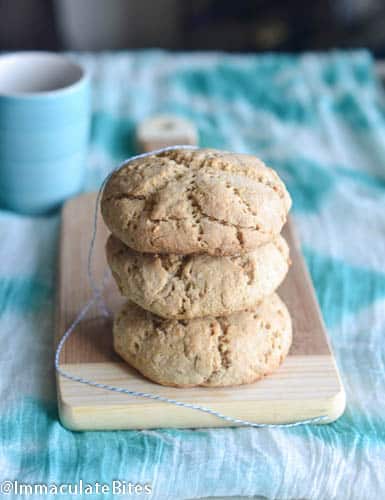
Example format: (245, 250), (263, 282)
(0, 51), (385, 500)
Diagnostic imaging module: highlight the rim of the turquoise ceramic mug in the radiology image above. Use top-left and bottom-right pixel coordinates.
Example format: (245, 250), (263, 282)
(0, 50), (89, 99)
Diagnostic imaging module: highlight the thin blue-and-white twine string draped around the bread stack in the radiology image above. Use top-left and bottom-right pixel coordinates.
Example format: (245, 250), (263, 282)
(55, 145), (327, 428)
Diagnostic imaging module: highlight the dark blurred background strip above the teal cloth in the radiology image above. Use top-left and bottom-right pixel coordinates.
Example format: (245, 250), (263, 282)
(0, 0), (385, 57)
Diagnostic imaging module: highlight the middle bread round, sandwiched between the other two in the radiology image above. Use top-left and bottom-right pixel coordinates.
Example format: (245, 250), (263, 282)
(106, 232), (289, 319)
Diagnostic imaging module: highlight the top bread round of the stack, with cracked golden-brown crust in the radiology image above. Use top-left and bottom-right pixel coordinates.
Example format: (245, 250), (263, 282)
(101, 149), (291, 255)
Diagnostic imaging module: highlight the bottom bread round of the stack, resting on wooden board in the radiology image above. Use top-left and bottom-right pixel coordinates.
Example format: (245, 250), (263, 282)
(113, 294), (292, 387)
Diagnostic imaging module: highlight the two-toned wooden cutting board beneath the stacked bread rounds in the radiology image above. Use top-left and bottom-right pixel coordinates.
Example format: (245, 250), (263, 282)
(56, 193), (345, 430)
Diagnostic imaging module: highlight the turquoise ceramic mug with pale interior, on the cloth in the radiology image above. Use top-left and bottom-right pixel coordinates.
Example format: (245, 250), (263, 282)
(0, 52), (90, 214)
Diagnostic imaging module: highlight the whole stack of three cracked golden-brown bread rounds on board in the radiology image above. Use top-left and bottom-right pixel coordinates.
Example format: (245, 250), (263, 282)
(101, 149), (292, 387)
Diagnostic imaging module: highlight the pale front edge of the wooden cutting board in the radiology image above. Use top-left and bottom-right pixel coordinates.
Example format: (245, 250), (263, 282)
(57, 356), (346, 431)
